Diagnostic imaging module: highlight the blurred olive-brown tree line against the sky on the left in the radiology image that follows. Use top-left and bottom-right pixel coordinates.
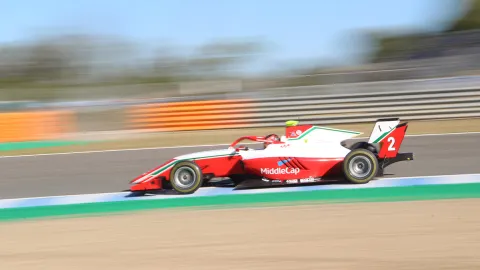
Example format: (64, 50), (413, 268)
(0, 34), (261, 86)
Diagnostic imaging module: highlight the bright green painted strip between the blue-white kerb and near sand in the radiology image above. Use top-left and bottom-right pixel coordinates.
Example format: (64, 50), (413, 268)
(0, 183), (480, 221)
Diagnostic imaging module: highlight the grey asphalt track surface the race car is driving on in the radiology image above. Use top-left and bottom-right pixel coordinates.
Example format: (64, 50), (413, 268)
(0, 133), (480, 199)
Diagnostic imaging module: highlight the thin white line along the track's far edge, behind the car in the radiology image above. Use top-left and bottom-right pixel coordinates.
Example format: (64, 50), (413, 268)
(0, 131), (480, 158)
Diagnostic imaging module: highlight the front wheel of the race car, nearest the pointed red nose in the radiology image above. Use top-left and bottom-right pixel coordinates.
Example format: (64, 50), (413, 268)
(170, 161), (203, 194)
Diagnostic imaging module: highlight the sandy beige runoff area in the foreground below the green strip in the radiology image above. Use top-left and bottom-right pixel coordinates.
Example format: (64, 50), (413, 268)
(0, 199), (480, 270)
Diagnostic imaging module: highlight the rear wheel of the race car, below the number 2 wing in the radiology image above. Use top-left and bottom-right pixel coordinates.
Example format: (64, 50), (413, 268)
(343, 148), (379, 184)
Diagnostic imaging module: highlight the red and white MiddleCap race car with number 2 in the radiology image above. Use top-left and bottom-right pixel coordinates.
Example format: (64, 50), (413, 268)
(130, 118), (413, 194)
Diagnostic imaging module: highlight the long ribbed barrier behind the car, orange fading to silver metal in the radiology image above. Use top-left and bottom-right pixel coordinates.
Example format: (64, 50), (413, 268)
(128, 87), (480, 131)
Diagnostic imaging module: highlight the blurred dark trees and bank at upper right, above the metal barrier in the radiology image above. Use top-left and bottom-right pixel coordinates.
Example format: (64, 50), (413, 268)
(272, 0), (480, 86)
